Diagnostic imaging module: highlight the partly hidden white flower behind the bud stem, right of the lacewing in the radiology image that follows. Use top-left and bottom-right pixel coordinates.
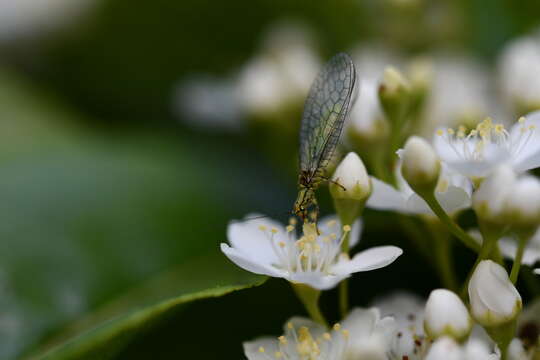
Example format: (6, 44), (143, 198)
(367, 162), (472, 216)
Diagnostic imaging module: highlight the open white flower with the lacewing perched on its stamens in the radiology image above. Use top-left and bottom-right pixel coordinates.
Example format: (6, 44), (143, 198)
(221, 217), (402, 290)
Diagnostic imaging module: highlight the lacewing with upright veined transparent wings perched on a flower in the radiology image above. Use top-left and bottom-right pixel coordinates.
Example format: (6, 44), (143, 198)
(293, 53), (356, 222)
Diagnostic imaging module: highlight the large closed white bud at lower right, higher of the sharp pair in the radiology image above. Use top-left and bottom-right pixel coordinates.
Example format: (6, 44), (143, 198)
(469, 260), (522, 327)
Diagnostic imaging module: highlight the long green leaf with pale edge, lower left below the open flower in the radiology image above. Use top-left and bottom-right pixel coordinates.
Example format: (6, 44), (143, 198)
(25, 254), (266, 360)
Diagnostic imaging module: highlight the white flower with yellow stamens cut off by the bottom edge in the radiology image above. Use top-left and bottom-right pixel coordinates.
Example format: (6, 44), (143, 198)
(244, 308), (394, 360)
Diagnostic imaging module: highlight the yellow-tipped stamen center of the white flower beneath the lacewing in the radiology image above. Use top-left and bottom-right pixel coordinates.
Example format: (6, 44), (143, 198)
(259, 219), (351, 275)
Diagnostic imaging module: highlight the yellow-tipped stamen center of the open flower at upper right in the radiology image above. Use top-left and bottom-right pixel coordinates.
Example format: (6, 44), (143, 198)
(437, 117), (536, 160)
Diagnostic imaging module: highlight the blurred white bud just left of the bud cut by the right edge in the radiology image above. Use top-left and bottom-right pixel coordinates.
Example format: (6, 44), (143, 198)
(473, 165), (516, 225)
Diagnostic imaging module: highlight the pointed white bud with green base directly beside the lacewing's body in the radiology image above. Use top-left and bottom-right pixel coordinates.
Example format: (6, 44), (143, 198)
(330, 152), (371, 202)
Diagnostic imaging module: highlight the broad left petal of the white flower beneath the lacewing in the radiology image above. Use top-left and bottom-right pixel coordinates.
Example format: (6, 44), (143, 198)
(227, 214), (287, 264)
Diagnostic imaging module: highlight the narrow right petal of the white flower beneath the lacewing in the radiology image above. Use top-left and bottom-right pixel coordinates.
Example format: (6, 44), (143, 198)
(332, 246), (403, 274)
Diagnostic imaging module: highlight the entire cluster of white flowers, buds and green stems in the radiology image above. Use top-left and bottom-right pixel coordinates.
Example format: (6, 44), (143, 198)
(217, 28), (540, 360)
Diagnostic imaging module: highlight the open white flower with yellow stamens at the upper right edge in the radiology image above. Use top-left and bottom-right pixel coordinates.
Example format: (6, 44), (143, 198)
(434, 111), (540, 178)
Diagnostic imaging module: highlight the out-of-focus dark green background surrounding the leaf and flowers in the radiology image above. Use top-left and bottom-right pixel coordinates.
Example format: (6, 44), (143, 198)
(0, 0), (540, 359)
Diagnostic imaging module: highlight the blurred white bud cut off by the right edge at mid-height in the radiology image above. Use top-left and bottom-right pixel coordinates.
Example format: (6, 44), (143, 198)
(506, 176), (540, 230)
